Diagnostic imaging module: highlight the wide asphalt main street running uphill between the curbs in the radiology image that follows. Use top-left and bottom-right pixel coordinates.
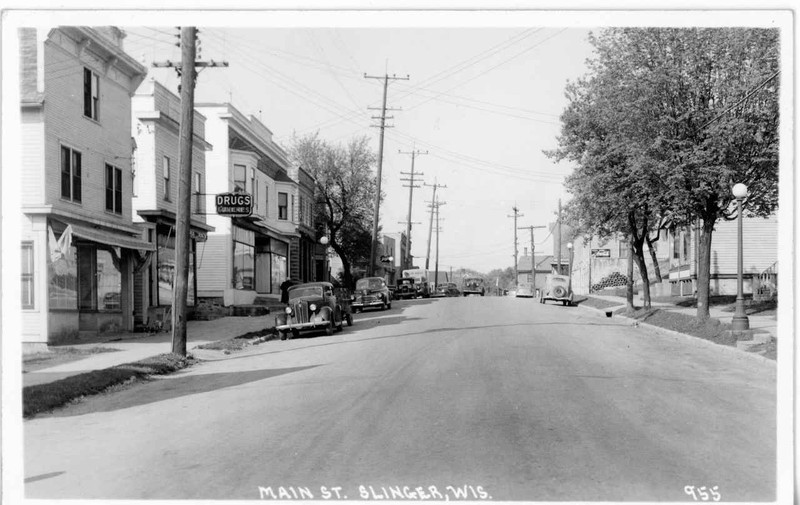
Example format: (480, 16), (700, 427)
(24, 297), (776, 501)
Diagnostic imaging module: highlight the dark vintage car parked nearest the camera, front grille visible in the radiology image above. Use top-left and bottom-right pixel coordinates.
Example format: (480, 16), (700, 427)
(275, 282), (353, 340)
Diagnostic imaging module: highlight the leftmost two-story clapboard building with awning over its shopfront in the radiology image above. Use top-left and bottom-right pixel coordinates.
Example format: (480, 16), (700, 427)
(18, 26), (154, 349)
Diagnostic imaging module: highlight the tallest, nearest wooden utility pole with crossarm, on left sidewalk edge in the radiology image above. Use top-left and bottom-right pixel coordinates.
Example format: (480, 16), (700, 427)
(153, 26), (228, 356)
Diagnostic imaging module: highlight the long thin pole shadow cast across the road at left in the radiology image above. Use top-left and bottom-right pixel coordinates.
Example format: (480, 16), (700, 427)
(41, 365), (320, 417)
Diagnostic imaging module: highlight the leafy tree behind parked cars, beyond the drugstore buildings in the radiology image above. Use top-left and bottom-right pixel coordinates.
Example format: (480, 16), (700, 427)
(289, 134), (376, 289)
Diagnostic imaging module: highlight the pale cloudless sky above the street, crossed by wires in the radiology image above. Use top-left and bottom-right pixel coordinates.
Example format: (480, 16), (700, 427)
(123, 25), (592, 272)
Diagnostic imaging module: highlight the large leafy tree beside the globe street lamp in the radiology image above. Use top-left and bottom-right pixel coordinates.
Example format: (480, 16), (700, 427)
(560, 28), (779, 318)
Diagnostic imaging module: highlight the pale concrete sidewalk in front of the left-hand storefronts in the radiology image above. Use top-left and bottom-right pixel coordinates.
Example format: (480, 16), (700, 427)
(22, 315), (275, 387)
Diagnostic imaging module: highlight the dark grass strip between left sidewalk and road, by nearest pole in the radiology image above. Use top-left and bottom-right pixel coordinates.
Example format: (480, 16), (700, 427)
(22, 353), (194, 418)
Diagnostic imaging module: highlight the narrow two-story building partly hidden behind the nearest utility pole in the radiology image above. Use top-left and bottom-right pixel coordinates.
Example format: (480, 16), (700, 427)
(131, 79), (213, 325)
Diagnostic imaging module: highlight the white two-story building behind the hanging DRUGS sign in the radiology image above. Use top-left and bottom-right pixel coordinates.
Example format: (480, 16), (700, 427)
(196, 103), (300, 306)
